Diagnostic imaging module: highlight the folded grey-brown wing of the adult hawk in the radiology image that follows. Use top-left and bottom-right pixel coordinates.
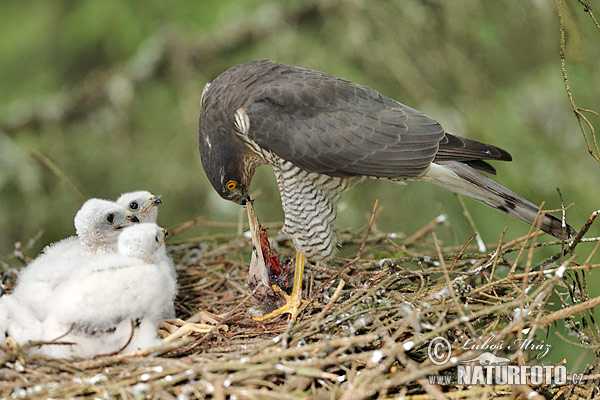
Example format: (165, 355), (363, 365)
(246, 68), (445, 178)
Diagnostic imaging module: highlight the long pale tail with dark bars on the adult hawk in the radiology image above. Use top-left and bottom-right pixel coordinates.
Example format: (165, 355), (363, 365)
(422, 161), (577, 239)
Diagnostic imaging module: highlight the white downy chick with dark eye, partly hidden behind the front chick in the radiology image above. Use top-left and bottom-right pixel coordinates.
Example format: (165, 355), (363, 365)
(13, 199), (138, 321)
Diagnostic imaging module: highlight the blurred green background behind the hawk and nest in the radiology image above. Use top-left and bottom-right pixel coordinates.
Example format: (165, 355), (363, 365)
(0, 0), (600, 366)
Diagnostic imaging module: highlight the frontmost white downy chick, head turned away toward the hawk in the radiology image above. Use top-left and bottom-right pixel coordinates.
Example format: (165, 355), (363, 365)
(40, 223), (175, 358)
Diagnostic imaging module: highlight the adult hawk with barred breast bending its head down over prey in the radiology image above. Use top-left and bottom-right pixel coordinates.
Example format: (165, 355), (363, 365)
(199, 61), (574, 317)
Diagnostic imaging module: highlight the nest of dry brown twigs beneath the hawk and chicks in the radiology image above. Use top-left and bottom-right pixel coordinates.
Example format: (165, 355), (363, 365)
(0, 214), (600, 400)
